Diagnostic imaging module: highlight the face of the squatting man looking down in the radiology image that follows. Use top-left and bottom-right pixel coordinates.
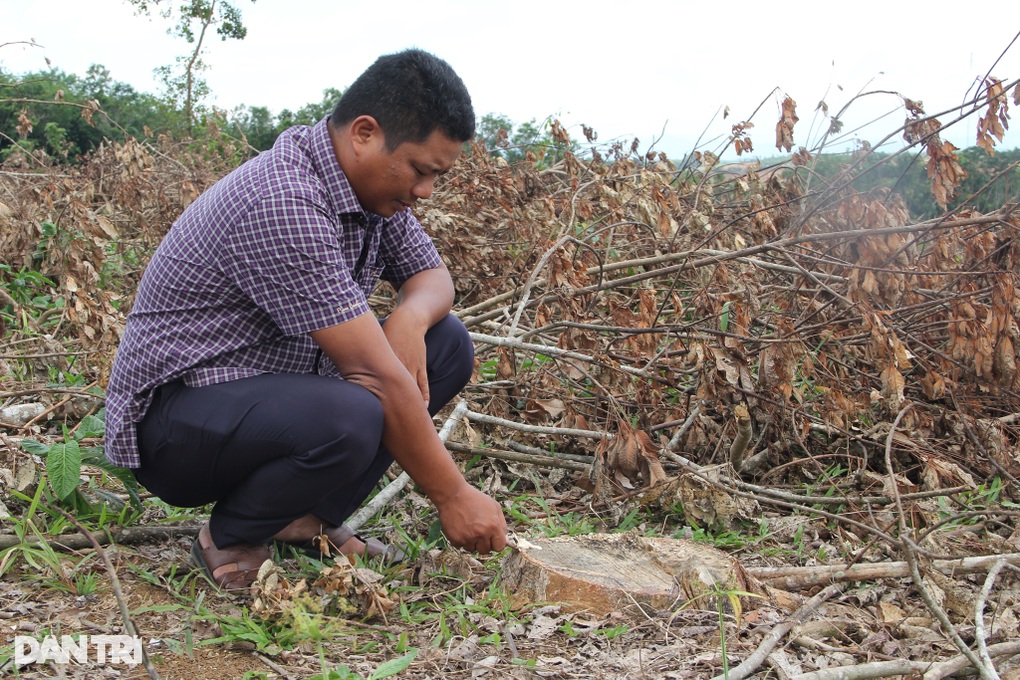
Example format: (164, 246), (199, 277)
(348, 124), (463, 217)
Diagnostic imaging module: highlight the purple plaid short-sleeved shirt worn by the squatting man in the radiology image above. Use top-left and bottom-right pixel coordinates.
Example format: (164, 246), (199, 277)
(106, 120), (441, 468)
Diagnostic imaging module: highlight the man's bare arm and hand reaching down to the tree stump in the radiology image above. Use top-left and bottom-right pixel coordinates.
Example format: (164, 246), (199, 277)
(311, 314), (507, 553)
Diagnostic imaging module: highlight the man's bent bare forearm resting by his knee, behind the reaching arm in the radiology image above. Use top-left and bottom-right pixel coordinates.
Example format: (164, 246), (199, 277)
(383, 263), (455, 404)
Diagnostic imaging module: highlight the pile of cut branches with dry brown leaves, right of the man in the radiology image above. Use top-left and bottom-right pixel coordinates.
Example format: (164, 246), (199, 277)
(422, 89), (1020, 489)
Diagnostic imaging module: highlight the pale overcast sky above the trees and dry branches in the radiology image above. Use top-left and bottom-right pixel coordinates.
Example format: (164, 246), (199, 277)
(0, 0), (1020, 159)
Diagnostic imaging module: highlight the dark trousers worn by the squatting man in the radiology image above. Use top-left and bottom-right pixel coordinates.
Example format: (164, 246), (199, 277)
(135, 316), (474, 547)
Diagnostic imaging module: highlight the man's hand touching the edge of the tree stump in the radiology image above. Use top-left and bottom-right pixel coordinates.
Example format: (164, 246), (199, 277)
(436, 482), (507, 553)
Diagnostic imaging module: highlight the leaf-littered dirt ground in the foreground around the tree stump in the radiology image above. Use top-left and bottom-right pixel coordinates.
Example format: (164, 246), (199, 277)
(0, 495), (1020, 679)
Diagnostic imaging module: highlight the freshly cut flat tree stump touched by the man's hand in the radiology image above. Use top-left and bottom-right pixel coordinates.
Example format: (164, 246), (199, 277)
(503, 533), (768, 615)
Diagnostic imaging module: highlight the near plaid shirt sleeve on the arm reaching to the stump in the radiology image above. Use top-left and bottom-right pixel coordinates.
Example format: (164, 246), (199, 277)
(224, 197), (370, 335)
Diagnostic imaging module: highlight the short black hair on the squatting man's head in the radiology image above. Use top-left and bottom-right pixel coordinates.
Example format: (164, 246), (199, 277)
(329, 49), (474, 151)
